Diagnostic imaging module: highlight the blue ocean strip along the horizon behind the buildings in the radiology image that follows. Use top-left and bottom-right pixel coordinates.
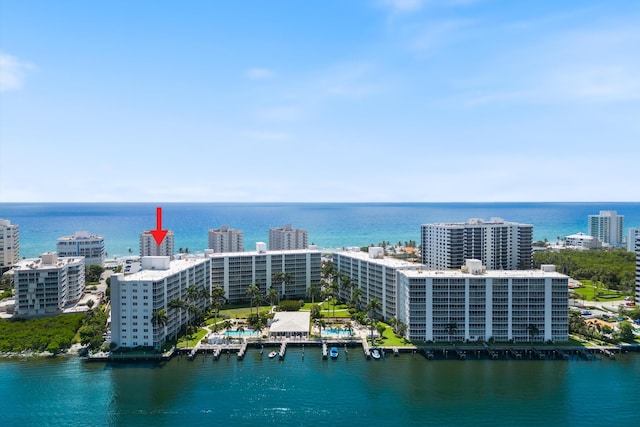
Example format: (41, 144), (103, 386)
(0, 202), (640, 257)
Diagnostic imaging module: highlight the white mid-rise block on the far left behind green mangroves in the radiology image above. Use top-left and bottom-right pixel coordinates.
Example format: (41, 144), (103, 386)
(14, 252), (85, 317)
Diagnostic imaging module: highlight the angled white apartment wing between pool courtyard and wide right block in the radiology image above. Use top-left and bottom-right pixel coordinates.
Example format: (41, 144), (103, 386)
(333, 247), (422, 319)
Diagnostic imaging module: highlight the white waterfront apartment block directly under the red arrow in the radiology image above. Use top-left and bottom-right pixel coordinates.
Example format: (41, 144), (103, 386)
(111, 256), (211, 349)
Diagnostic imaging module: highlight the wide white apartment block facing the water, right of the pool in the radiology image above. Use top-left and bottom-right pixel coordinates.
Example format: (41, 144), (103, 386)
(397, 260), (569, 342)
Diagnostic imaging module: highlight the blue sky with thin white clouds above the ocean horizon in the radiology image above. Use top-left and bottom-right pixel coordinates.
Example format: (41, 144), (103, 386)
(0, 0), (640, 202)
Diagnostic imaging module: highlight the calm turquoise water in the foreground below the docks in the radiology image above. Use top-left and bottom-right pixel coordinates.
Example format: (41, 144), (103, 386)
(0, 347), (640, 427)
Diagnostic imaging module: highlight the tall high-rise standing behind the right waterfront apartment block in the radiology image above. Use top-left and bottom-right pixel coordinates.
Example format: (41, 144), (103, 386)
(421, 218), (533, 270)
